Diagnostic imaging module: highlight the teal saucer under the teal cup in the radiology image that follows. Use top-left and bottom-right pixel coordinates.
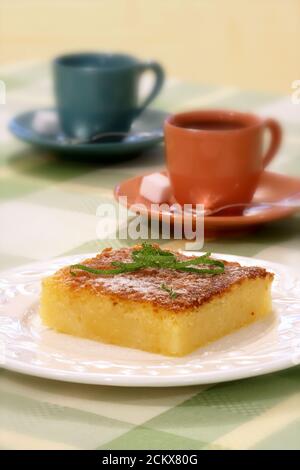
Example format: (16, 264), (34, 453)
(9, 108), (167, 161)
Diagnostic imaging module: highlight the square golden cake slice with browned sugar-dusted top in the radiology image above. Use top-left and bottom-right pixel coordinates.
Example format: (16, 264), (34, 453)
(40, 245), (273, 356)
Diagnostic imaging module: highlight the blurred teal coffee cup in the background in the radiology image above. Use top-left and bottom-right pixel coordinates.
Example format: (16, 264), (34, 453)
(54, 53), (164, 139)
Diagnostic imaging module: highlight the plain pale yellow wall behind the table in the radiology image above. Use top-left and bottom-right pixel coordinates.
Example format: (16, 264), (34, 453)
(0, 0), (300, 93)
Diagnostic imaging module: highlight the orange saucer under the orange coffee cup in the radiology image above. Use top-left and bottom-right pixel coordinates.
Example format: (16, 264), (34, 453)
(114, 171), (300, 233)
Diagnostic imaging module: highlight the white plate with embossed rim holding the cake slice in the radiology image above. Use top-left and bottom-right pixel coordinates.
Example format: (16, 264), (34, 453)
(0, 253), (300, 387)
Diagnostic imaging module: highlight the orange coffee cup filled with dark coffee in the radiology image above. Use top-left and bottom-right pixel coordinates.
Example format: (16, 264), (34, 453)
(164, 110), (282, 209)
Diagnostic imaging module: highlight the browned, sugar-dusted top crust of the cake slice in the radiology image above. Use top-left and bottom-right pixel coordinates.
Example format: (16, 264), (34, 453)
(56, 248), (273, 311)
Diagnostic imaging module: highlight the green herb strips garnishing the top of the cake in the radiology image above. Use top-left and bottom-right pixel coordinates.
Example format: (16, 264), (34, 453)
(70, 242), (224, 276)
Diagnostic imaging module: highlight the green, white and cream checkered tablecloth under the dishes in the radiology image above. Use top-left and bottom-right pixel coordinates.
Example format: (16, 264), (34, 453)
(0, 63), (300, 449)
